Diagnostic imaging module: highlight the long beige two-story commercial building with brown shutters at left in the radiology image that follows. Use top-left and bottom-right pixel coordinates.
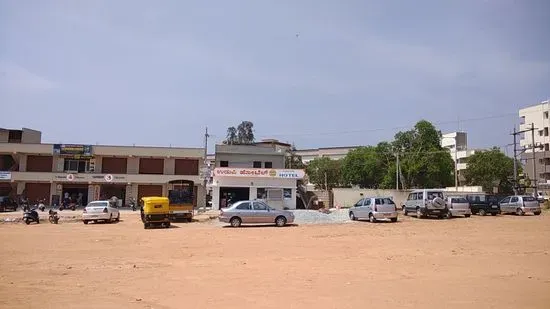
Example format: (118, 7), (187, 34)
(0, 129), (205, 207)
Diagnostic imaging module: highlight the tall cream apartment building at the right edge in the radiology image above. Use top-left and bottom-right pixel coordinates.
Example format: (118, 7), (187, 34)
(519, 100), (550, 187)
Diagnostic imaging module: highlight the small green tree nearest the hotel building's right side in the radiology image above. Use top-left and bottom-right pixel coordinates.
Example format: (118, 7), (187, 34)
(306, 157), (342, 190)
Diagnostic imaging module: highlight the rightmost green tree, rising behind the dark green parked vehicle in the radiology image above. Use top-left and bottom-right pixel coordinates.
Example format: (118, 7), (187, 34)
(464, 147), (521, 194)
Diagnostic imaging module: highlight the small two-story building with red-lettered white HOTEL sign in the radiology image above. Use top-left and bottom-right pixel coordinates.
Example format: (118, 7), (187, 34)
(211, 142), (304, 209)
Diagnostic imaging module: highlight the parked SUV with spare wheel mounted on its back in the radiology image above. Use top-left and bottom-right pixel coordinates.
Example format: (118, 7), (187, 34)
(402, 189), (449, 218)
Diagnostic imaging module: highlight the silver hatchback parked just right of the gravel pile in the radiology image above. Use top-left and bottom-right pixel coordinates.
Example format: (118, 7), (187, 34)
(349, 197), (397, 223)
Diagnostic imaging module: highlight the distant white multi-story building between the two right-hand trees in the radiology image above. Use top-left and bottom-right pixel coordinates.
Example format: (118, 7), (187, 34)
(441, 132), (475, 185)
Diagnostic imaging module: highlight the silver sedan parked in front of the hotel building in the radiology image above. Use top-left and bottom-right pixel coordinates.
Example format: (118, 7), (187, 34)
(219, 201), (294, 227)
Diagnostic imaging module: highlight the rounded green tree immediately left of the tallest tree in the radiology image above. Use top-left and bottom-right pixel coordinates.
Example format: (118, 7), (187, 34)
(342, 146), (385, 188)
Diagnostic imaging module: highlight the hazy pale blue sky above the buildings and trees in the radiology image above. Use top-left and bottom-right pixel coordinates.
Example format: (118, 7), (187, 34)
(0, 0), (550, 153)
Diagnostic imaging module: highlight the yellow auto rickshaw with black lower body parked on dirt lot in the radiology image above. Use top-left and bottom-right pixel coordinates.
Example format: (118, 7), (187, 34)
(140, 196), (170, 229)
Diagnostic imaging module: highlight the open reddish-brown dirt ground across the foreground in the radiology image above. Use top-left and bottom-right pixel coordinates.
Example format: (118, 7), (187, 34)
(0, 212), (550, 309)
